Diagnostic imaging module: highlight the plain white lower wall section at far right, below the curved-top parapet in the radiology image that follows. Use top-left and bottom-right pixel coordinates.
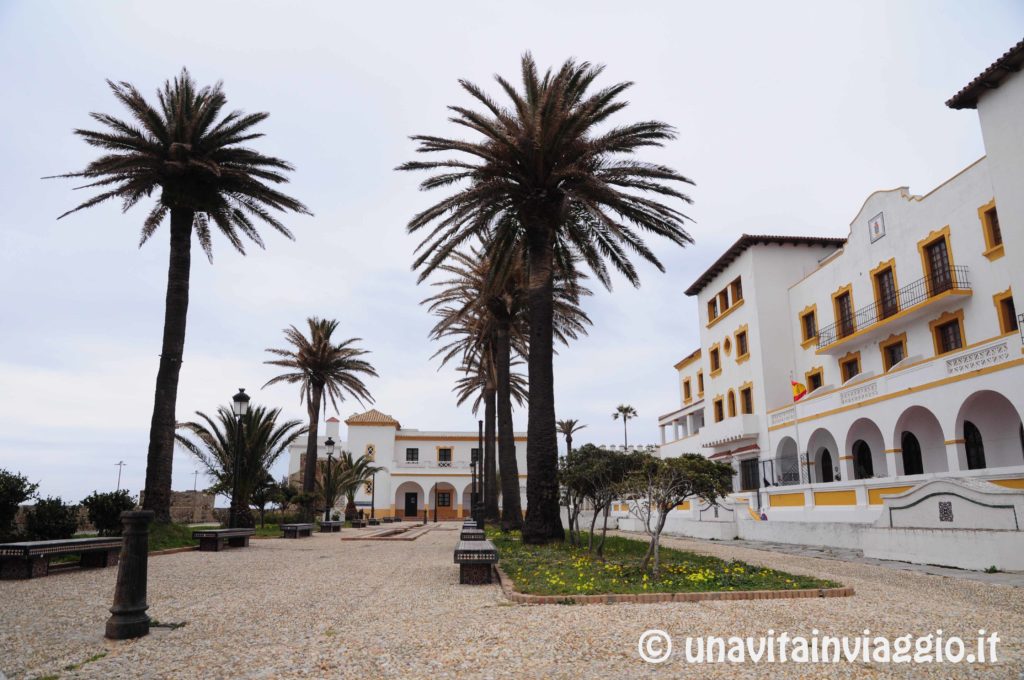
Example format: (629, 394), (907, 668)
(861, 527), (1024, 571)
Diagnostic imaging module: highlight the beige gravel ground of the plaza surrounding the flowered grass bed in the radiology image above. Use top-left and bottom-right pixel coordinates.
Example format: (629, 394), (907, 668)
(0, 526), (1024, 680)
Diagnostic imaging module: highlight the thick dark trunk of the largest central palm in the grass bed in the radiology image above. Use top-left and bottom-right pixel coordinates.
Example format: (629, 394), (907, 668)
(522, 220), (565, 544)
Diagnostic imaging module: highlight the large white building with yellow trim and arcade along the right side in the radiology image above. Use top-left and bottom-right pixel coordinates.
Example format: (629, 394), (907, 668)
(638, 42), (1024, 568)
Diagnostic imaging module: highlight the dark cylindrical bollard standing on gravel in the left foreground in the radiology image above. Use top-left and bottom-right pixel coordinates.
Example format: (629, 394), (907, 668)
(105, 510), (156, 640)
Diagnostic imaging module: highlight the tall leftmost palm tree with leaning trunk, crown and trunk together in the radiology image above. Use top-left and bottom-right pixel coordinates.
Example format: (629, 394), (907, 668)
(58, 69), (310, 521)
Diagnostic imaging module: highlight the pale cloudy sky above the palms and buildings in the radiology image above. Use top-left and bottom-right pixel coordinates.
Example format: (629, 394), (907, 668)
(0, 0), (1024, 501)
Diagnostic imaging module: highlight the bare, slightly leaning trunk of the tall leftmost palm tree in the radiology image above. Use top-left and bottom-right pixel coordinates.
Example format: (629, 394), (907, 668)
(142, 208), (195, 522)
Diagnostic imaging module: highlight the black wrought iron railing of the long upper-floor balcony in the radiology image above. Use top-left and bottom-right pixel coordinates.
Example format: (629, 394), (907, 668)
(818, 266), (971, 349)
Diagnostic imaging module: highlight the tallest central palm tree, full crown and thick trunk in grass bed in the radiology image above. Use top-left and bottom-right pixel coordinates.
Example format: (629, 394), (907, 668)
(398, 53), (692, 543)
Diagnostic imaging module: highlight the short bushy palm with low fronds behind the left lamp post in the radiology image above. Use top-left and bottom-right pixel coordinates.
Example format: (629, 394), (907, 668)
(174, 406), (306, 526)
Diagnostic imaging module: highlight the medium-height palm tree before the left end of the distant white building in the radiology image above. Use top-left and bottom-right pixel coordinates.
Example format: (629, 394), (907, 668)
(263, 316), (377, 494)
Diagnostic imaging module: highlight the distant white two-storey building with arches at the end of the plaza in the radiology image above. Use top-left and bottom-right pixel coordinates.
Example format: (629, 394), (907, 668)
(288, 409), (526, 519)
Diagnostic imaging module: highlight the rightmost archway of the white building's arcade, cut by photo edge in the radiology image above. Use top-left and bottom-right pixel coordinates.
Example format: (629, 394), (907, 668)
(956, 389), (1022, 470)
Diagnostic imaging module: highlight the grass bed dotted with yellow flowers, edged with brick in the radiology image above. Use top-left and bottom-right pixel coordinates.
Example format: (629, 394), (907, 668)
(487, 532), (839, 595)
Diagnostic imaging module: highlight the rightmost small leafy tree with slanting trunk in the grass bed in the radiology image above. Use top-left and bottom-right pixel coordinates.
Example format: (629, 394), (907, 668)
(620, 454), (734, 577)
